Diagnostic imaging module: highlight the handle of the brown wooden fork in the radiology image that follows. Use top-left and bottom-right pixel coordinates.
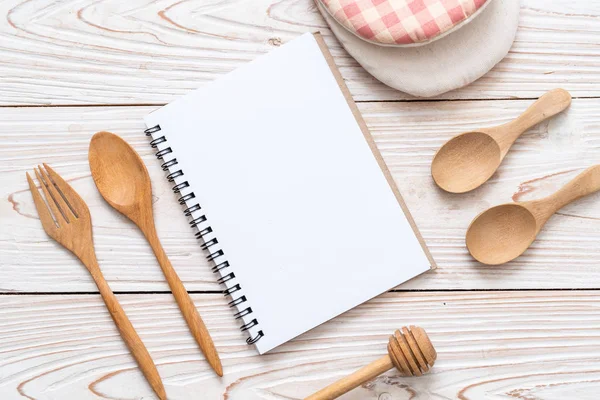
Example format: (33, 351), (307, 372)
(92, 271), (167, 400)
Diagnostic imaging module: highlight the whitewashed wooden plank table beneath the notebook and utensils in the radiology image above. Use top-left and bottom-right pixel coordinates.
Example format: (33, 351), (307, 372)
(0, 0), (600, 400)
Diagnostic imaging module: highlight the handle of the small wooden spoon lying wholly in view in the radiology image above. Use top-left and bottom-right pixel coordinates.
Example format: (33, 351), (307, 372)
(510, 89), (571, 135)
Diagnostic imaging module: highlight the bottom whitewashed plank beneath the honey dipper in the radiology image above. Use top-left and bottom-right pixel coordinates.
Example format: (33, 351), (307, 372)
(0, 291), (600, 400)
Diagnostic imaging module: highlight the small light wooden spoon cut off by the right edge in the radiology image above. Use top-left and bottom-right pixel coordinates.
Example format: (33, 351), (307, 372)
(467, 165), (600, 265)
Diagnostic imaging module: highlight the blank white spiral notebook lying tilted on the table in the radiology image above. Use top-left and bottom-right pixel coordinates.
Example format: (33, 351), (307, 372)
(145, 34), (433, 353)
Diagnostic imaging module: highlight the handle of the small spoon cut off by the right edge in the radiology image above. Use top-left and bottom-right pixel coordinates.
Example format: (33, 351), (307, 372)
(525, 165), (600, 222)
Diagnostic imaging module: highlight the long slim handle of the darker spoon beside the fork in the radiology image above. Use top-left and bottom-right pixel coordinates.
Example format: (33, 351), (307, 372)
(146, 229), (223, 376)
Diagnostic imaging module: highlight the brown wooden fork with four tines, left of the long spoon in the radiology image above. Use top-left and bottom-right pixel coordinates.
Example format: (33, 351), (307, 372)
(27, 164), (167, 400)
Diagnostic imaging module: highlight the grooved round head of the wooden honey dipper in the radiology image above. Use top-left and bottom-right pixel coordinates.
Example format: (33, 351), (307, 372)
(388, 326), (437, 376)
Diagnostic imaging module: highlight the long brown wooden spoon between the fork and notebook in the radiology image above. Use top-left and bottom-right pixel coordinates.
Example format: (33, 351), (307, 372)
(88, 132), (223, 376)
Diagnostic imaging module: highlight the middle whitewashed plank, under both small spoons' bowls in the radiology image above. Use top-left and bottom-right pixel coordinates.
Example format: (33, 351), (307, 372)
(0, 99), (600, 292)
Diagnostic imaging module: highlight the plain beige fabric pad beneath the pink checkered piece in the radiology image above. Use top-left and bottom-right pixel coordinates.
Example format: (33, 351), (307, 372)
(317, 0), (520, 97)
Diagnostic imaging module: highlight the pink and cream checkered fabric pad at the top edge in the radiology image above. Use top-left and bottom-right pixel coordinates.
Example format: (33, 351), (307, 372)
(319, 0), (491, 45)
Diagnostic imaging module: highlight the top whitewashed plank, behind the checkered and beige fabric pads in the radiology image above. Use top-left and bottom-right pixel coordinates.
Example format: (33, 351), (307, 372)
(0, 0), (600, 105)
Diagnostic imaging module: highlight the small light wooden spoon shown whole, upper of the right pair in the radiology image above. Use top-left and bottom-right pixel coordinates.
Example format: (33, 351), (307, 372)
(431, 89), (571, 193)
